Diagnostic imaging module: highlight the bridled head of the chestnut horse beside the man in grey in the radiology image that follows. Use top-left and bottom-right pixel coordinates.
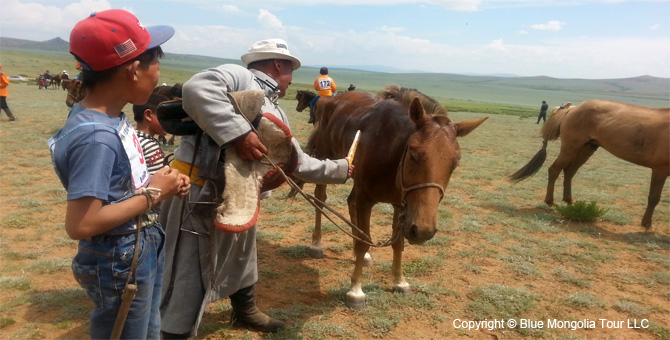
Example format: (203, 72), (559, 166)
(396, 97), (487, 244)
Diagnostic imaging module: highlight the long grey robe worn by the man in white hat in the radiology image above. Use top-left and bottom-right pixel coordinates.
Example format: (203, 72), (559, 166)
(161, 64), (349, 335)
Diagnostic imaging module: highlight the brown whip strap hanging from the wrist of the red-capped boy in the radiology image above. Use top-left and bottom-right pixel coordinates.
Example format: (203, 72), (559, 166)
(110, 187), (161, 340)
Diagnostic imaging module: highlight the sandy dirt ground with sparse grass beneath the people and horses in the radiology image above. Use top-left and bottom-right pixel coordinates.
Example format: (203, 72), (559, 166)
(0, 86), (670, 339)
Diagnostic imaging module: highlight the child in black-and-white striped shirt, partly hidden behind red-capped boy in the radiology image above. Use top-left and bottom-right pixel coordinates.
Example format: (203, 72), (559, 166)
(133, 93), (170, 175)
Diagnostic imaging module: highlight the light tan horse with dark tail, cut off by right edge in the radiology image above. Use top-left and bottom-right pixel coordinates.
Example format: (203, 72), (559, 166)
(510, 100), (670, 230)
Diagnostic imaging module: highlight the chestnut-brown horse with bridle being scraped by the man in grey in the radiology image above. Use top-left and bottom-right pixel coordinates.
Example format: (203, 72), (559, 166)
(307, 86), (487, 309)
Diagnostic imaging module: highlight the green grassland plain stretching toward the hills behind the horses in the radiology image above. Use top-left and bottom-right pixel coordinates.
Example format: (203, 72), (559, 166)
(0, 48), (670, 113)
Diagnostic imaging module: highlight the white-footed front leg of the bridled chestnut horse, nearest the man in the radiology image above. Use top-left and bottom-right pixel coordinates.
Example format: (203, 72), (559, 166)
(344, 193), (372, 310)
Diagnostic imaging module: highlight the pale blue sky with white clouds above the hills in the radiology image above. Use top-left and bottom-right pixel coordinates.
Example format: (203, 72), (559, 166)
(0, 0), (670, 79)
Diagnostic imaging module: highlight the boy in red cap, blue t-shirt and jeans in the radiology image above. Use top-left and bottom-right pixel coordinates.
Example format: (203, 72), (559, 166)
(49, 9), (190, 339)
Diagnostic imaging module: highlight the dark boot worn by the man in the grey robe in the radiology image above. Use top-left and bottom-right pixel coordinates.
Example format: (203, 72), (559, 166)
(230, 285), (286, 333)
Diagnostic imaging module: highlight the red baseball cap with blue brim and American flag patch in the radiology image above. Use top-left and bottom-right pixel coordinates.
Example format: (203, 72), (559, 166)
(70, 9), (174, 71)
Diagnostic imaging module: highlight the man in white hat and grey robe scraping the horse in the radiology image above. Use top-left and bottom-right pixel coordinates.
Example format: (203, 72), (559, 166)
(161, 39), (353, 339)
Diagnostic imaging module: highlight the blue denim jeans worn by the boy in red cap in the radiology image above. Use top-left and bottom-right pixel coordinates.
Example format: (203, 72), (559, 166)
(72, 223), (165, 339)
